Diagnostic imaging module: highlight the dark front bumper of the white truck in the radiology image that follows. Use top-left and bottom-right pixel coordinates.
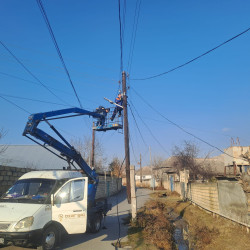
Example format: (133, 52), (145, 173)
(0, 229), (43, 246)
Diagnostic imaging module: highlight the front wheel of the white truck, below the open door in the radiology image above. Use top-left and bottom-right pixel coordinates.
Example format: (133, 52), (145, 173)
(40, 226), (58, 250)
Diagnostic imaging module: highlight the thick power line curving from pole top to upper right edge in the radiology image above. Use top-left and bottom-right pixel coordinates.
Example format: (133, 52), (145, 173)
(131, 25), (250, 81)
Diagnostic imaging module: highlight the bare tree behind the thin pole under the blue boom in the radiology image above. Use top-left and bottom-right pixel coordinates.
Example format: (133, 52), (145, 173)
(71, 136), (106, 169)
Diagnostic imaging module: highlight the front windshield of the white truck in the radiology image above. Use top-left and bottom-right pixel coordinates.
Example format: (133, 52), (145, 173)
(1, 179), (56, 203)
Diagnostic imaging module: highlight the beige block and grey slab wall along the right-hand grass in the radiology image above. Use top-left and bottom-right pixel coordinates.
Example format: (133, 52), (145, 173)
(187, 180), (250, 227)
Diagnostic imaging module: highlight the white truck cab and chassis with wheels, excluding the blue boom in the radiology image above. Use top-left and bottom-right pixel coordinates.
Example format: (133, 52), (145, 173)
(0, 170), (106, 249)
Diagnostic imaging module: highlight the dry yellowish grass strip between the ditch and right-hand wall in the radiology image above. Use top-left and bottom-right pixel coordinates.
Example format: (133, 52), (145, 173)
(161, 190), (250, 250)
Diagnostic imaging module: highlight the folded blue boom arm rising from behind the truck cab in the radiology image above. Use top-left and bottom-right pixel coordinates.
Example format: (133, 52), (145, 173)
(23, 108), (104, 202)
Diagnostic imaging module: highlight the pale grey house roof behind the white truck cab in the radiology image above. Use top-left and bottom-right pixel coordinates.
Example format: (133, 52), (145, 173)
(0, 145), (67, 170)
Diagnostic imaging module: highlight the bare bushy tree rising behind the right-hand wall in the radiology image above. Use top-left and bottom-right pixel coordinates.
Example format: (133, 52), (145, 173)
(173, 141), (213, 180)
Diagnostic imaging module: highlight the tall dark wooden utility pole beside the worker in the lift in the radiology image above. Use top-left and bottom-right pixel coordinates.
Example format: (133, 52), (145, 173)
(122, 71), (131, 204)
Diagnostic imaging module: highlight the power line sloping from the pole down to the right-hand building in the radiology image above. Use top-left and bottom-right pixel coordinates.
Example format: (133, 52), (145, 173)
(131, 87), (240, 159)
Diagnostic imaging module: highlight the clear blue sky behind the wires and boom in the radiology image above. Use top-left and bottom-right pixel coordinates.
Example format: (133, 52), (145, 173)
(0, 0), (250, 168)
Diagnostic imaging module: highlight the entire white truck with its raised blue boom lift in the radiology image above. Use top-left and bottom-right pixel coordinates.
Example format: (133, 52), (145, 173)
(0, 108), (118, 249)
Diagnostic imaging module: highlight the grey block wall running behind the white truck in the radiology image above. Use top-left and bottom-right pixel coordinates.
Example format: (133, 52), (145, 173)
(0, 166), (122, 199)
